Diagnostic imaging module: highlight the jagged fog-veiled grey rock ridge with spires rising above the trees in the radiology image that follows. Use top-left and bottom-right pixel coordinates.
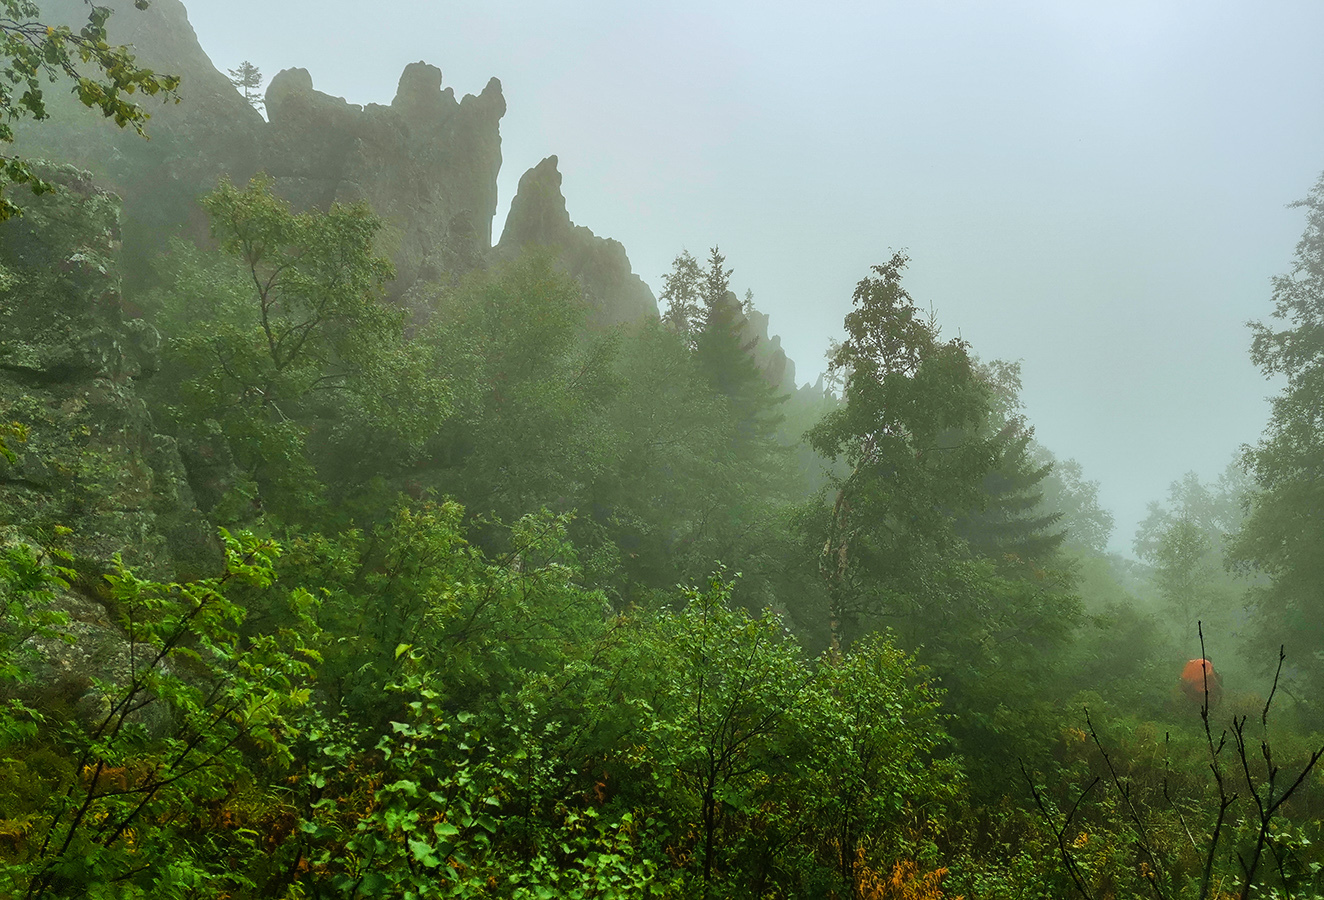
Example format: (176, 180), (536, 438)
(17, 0), (657, 324)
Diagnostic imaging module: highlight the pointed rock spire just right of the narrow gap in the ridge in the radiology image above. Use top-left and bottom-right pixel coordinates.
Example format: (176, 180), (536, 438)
(497, 156), (658, 327)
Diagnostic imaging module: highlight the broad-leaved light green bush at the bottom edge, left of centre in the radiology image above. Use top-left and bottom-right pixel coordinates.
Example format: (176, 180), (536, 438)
(302, 672), (666, 900)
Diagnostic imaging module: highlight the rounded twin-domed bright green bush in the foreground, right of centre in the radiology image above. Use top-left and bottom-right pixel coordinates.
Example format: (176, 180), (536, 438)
(585, 572), (961, 896)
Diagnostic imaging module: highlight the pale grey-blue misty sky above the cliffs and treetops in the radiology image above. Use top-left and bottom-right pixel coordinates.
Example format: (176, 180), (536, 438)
(184, 0), (1324, 551)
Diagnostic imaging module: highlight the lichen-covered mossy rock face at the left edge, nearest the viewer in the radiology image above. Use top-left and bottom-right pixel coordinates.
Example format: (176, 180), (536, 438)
(0, 168), (220, 578)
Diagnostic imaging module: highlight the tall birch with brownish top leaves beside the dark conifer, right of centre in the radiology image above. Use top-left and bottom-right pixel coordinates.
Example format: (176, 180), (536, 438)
(809, 254), (994, 634)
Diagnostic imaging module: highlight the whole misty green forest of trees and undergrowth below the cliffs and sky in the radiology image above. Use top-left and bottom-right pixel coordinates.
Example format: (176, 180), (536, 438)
(0, 0), (1324, 900)
